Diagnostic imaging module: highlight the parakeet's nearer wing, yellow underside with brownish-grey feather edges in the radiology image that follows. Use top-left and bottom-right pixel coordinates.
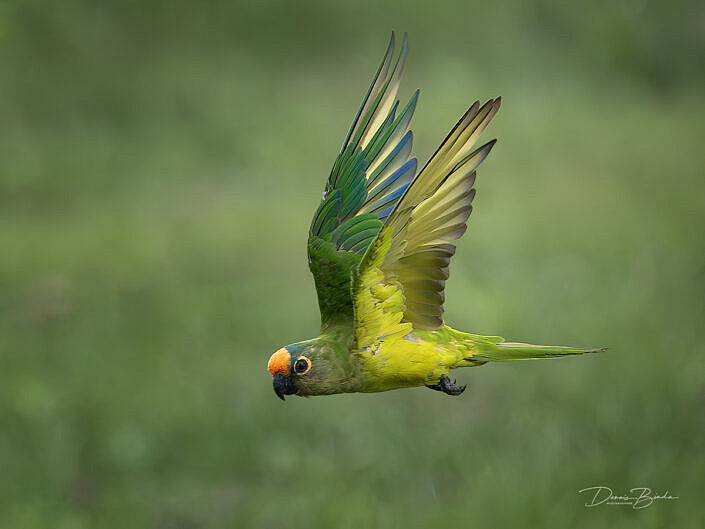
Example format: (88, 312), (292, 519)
(353, 98), (500, 352)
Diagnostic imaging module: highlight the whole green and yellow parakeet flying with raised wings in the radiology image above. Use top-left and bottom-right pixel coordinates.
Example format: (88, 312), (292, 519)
(268, 33), (604, 400)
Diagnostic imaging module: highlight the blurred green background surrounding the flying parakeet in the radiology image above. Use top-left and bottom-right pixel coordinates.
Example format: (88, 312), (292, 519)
(0, 0), (705, 529)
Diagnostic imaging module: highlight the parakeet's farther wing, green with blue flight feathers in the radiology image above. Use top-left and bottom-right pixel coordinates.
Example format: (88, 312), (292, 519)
(308, 33), (418, 327)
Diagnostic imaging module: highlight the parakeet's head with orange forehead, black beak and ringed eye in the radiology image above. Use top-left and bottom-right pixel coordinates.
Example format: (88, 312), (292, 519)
(267, 340), (348, 400)
